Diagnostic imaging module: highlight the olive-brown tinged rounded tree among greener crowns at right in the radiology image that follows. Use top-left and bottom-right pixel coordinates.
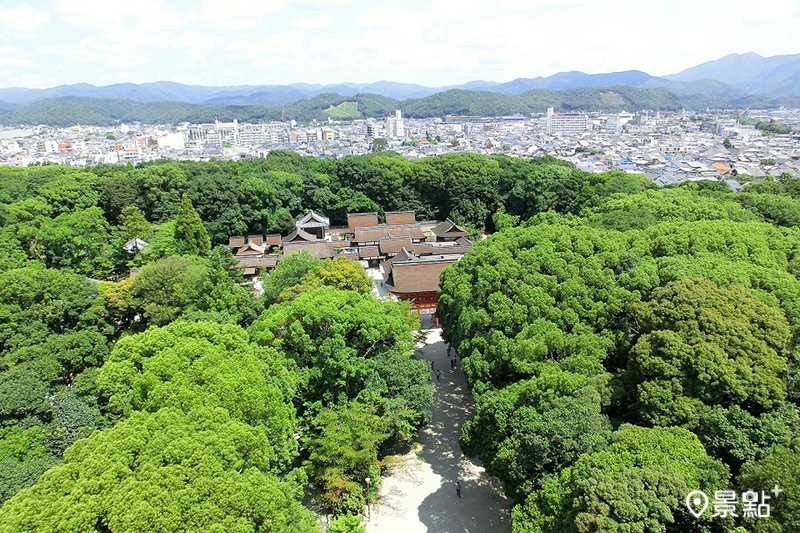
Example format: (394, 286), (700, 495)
(626, 278), (791, 429)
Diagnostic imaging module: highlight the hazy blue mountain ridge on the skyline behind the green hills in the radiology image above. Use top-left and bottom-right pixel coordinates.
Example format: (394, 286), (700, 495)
(0, 52), (800, 110)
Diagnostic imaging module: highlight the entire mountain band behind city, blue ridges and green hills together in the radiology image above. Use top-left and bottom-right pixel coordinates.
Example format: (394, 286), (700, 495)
(0, 52), (800, 126)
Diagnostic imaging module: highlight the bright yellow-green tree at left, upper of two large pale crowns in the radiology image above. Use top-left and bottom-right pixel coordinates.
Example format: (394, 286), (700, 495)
(96, 322), (297, 470)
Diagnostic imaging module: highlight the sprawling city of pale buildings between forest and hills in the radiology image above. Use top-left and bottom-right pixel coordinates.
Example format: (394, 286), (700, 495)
(0, 105), (800, 187)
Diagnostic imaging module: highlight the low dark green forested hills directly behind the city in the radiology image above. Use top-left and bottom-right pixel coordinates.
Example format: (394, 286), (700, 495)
(0, 85), (798, 127)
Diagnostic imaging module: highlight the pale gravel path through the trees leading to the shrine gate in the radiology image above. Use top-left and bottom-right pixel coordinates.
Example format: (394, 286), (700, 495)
(367, 328), (511, 533)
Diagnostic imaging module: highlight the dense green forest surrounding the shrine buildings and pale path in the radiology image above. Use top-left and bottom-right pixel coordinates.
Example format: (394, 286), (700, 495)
(0, 151), (800, 533)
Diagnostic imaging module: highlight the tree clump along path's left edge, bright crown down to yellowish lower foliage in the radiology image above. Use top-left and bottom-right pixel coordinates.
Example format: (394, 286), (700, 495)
(248, 286), (433, 513)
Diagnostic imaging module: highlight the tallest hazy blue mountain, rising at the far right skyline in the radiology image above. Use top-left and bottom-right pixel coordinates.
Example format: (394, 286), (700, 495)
(665, 52), (800, 97)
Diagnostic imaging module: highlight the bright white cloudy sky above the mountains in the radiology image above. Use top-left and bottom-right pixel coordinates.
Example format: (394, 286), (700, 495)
(0, 0), (800, 88)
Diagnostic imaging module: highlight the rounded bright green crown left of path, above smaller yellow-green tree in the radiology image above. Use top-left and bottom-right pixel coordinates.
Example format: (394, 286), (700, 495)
(253, 286), (431, 430)
